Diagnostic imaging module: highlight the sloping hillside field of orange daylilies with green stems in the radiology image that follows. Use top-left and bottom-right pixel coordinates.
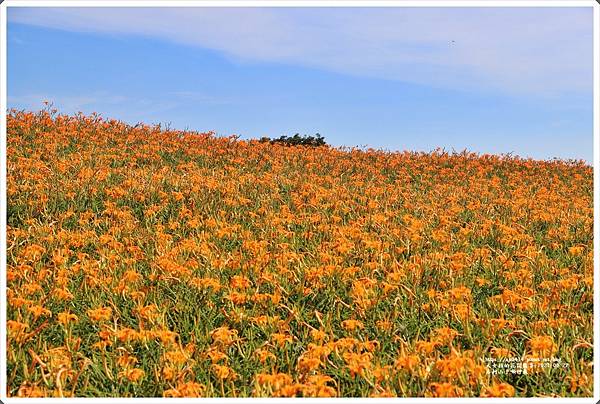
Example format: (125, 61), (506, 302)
(2, 111), (593, 397)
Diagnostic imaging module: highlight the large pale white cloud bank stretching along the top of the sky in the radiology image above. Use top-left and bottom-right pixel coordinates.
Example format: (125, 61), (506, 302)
(9, 7), (592, 96)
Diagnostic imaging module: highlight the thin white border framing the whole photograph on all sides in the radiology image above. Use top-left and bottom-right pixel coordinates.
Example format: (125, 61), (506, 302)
(0, 0), (600, 404)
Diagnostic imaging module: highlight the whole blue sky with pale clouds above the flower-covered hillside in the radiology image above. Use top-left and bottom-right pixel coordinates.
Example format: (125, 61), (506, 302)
(7, 7), (593, 163)
